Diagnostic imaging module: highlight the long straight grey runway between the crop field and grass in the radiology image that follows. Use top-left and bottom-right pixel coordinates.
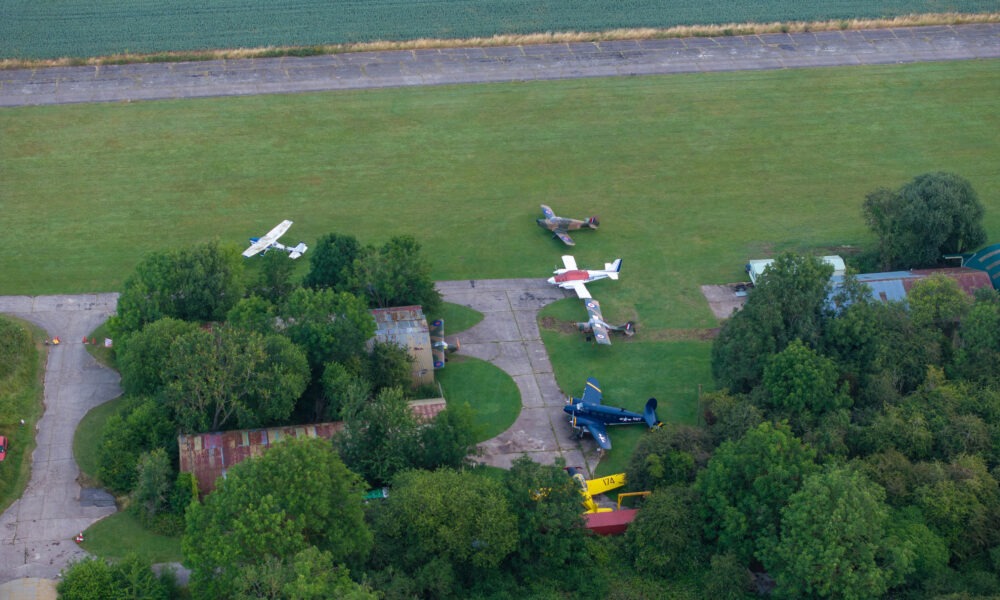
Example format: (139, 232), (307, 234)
(0, 23), (1000, 106)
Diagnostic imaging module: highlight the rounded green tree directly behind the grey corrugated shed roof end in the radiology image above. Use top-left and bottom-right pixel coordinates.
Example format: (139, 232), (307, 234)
(351, 235), (441, 314)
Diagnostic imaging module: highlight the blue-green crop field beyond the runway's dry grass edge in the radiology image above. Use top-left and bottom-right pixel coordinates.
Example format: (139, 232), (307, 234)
(0, 0), (997, 59)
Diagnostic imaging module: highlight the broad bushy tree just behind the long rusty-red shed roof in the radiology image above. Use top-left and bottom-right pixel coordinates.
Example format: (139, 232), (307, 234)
(163, 327), (309, 433)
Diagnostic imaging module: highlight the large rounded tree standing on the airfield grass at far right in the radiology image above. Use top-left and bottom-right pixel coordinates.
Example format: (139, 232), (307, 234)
(863, 172), (986, 270)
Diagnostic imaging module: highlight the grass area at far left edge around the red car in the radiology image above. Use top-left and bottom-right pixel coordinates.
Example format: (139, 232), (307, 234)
(0, 315), (47, 513)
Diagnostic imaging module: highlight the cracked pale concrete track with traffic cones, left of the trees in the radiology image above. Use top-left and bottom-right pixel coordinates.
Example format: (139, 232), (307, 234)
(0, 294), (121, 583)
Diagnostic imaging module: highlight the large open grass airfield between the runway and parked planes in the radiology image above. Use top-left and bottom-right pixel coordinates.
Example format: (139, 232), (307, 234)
(0, 61), (1000, 332)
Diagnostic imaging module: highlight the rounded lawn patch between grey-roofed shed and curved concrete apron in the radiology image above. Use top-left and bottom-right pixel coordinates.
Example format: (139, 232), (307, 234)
(435, 354), (521, 442)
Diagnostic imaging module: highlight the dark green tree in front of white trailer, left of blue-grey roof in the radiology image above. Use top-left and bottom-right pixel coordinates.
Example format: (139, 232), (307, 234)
(712, 254), (833, 393)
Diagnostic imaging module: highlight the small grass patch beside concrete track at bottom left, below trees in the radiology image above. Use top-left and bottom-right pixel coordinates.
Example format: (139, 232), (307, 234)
(80, 511), (183, 564)
